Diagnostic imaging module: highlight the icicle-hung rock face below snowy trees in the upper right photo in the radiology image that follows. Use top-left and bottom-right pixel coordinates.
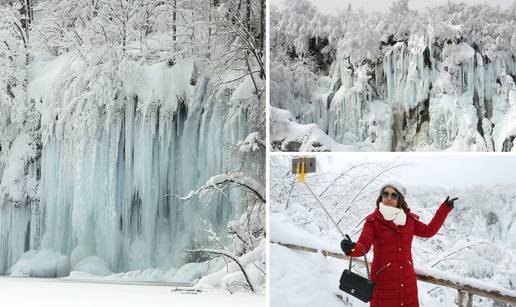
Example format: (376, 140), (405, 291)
(300, 39), (516, 151)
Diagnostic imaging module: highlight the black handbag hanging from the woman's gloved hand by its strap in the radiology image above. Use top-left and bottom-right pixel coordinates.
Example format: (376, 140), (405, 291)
(339, 246), (374, 303)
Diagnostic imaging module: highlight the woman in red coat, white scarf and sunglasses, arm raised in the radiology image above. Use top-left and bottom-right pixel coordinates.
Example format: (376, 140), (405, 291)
(341, 182), (458, 307)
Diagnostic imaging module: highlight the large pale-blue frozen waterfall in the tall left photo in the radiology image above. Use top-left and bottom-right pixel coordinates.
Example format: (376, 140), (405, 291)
(0, 59), (263, 276)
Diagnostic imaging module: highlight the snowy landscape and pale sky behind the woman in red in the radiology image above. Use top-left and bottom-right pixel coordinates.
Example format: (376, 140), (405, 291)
(270, 154), (516, 307)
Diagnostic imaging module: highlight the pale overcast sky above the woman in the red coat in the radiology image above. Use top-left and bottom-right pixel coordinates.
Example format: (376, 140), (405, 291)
(317, 153), (516, 188)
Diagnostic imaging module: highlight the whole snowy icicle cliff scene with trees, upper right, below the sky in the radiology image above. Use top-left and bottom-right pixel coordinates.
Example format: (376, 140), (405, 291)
(270, 0), (516, 151)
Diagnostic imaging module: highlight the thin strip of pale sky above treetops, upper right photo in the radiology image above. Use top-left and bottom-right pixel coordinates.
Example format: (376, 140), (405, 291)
(271, 0), (514, 14)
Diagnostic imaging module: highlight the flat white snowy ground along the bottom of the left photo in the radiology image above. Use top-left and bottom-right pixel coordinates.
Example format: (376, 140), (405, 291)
(0, 277), (265, 307)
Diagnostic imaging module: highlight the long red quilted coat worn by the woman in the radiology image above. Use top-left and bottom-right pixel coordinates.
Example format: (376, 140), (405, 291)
(350, 203), (451, 307)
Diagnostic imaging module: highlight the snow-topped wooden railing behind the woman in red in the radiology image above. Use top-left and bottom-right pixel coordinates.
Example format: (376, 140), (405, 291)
(271, 242), (516, 307)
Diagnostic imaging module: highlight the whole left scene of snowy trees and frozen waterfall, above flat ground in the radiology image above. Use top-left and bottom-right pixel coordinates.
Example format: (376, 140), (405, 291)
(0, 0), (266, 300)
